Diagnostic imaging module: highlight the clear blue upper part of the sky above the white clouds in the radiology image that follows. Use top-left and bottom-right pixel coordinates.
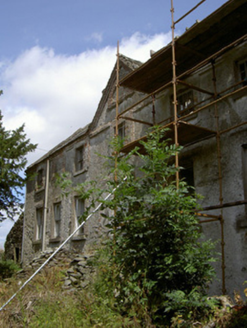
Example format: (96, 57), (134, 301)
(0, 0), (225, 60)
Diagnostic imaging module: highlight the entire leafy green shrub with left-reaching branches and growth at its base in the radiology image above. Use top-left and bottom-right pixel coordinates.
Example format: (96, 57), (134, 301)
(50, 129), (214, 327)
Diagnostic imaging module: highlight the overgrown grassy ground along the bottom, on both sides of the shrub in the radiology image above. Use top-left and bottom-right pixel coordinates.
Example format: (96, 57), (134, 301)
(0, 267), (247, 328)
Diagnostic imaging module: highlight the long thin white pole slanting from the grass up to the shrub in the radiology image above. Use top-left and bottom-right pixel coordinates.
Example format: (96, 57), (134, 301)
(0, 177), (127, 311)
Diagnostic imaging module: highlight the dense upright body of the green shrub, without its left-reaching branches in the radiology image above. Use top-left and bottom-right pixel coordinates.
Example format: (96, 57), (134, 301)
(100, 129), (214, 324)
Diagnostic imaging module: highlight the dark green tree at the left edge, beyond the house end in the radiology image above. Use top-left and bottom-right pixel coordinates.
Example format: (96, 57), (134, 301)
(0, 112), (37, 222)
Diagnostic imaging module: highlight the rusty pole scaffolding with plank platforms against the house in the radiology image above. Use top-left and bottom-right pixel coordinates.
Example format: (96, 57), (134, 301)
(116, 0), (247, 294)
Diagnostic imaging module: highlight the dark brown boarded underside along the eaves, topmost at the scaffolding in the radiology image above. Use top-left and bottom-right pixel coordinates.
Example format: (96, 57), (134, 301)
(120, 0), (247, 94)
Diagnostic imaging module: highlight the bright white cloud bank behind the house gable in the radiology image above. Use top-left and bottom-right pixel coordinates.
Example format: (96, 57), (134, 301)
(0, 33), (170, 163)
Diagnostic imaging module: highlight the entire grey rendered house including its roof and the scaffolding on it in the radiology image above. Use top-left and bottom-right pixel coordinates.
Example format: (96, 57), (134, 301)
(22, 0), (247, 293)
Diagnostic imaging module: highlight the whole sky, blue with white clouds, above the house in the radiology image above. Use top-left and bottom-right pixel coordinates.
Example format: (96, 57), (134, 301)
(0, 0), (226, 247)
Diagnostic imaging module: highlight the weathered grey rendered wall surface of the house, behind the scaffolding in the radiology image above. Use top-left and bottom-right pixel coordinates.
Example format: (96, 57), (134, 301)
(22, 1), (247, 293)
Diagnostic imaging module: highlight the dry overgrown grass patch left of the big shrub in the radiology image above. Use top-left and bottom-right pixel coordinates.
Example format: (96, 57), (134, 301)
(0, 267), (133, 328)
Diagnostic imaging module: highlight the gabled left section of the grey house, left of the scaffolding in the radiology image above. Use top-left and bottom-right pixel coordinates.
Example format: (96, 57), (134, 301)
(22, 56), (144, 265)
